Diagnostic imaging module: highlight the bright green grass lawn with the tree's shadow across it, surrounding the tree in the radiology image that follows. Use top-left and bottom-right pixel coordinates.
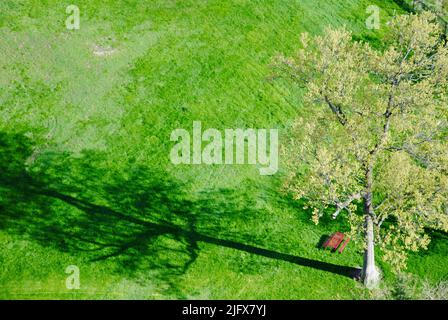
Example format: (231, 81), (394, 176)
(0, 0), (448, 299)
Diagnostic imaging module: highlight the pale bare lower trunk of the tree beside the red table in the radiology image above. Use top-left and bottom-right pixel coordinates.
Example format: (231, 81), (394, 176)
(361, 206), (380, 289)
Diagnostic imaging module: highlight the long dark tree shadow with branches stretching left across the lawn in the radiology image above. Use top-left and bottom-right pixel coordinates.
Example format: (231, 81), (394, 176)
(0, 133), (355, 298)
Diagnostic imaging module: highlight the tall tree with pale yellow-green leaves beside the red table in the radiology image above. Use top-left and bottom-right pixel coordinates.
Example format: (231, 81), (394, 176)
(275, 12), (448, 288)
